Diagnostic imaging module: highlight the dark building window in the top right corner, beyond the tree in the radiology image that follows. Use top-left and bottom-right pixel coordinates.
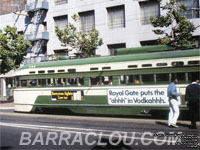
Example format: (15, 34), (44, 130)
(178, 0), (200, 19)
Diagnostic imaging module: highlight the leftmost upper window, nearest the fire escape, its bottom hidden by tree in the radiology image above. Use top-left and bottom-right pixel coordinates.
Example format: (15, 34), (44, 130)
(54, 15), (68, 30)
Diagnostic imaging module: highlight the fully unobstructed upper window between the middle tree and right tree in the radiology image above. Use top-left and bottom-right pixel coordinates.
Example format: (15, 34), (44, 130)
(107, 6), (125, 29)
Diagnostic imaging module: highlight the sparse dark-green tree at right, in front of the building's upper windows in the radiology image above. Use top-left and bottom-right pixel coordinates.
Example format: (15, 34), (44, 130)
(150, 0), (196, 49)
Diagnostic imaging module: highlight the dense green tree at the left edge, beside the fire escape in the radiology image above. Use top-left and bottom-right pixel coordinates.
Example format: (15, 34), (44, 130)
(0, 26), (31, 74)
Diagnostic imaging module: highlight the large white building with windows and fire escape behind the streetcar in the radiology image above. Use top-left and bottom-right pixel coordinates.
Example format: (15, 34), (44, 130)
(0, 0), (200, 100)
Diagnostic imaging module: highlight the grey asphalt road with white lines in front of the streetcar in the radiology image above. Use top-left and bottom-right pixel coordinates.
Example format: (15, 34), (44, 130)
(0, 110), (200, 150)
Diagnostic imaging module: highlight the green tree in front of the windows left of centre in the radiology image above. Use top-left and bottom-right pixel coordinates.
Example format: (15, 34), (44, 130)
(55, 15), (103, 57)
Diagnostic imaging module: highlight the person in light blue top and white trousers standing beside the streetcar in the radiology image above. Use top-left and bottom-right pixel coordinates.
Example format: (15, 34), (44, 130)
(167, 78), (181, 128)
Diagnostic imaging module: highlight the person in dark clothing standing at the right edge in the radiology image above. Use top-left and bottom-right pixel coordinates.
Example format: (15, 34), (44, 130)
(185, 79), (200, 129)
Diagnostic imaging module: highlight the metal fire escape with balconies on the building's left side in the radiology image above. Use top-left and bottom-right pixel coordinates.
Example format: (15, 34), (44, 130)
(25, 0), (49, 57)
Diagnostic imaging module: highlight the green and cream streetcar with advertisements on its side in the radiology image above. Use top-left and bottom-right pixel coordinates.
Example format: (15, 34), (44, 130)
(14, 46), (200, 115)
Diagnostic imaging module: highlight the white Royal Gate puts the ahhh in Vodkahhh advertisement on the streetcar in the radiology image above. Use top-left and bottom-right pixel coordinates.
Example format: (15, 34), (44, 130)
(108, 88), (180, 106)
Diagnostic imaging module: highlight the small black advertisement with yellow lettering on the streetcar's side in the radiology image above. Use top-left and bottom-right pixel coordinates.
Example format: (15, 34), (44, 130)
(51, 91), (84, 101)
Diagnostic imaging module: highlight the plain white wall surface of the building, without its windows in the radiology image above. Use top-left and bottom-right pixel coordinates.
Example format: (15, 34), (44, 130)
(0, 0), (200, 55)
